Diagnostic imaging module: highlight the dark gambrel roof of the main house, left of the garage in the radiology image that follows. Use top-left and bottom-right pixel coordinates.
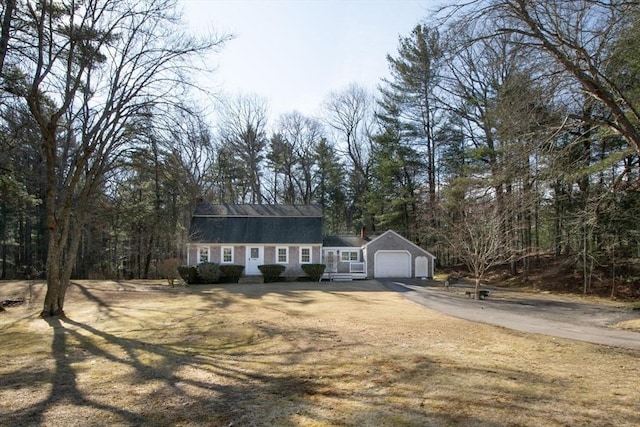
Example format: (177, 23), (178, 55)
(189, 204), (322, 244)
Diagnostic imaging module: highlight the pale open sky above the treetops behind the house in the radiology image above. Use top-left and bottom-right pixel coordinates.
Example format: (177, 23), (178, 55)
(184, 0), (439, 120)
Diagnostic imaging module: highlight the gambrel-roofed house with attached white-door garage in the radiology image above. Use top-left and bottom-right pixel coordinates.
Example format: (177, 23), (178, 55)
(187, 204), (435, 280)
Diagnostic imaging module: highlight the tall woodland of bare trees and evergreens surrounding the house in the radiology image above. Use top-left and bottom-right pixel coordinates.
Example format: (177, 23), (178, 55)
(0, 0), (640, 315)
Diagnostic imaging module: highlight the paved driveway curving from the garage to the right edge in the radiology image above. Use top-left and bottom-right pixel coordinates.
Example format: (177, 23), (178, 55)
(380, 279), (640, 350)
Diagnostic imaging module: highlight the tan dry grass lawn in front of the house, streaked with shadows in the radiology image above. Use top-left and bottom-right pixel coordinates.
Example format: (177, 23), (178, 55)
(0, 281), (640, 426)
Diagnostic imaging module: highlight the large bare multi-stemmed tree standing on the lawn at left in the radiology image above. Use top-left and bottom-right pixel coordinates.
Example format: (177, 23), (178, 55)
(1, 0), (224, 317)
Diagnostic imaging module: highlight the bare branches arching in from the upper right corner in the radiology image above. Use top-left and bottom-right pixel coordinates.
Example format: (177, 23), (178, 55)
(453, 0), (640, 154)
